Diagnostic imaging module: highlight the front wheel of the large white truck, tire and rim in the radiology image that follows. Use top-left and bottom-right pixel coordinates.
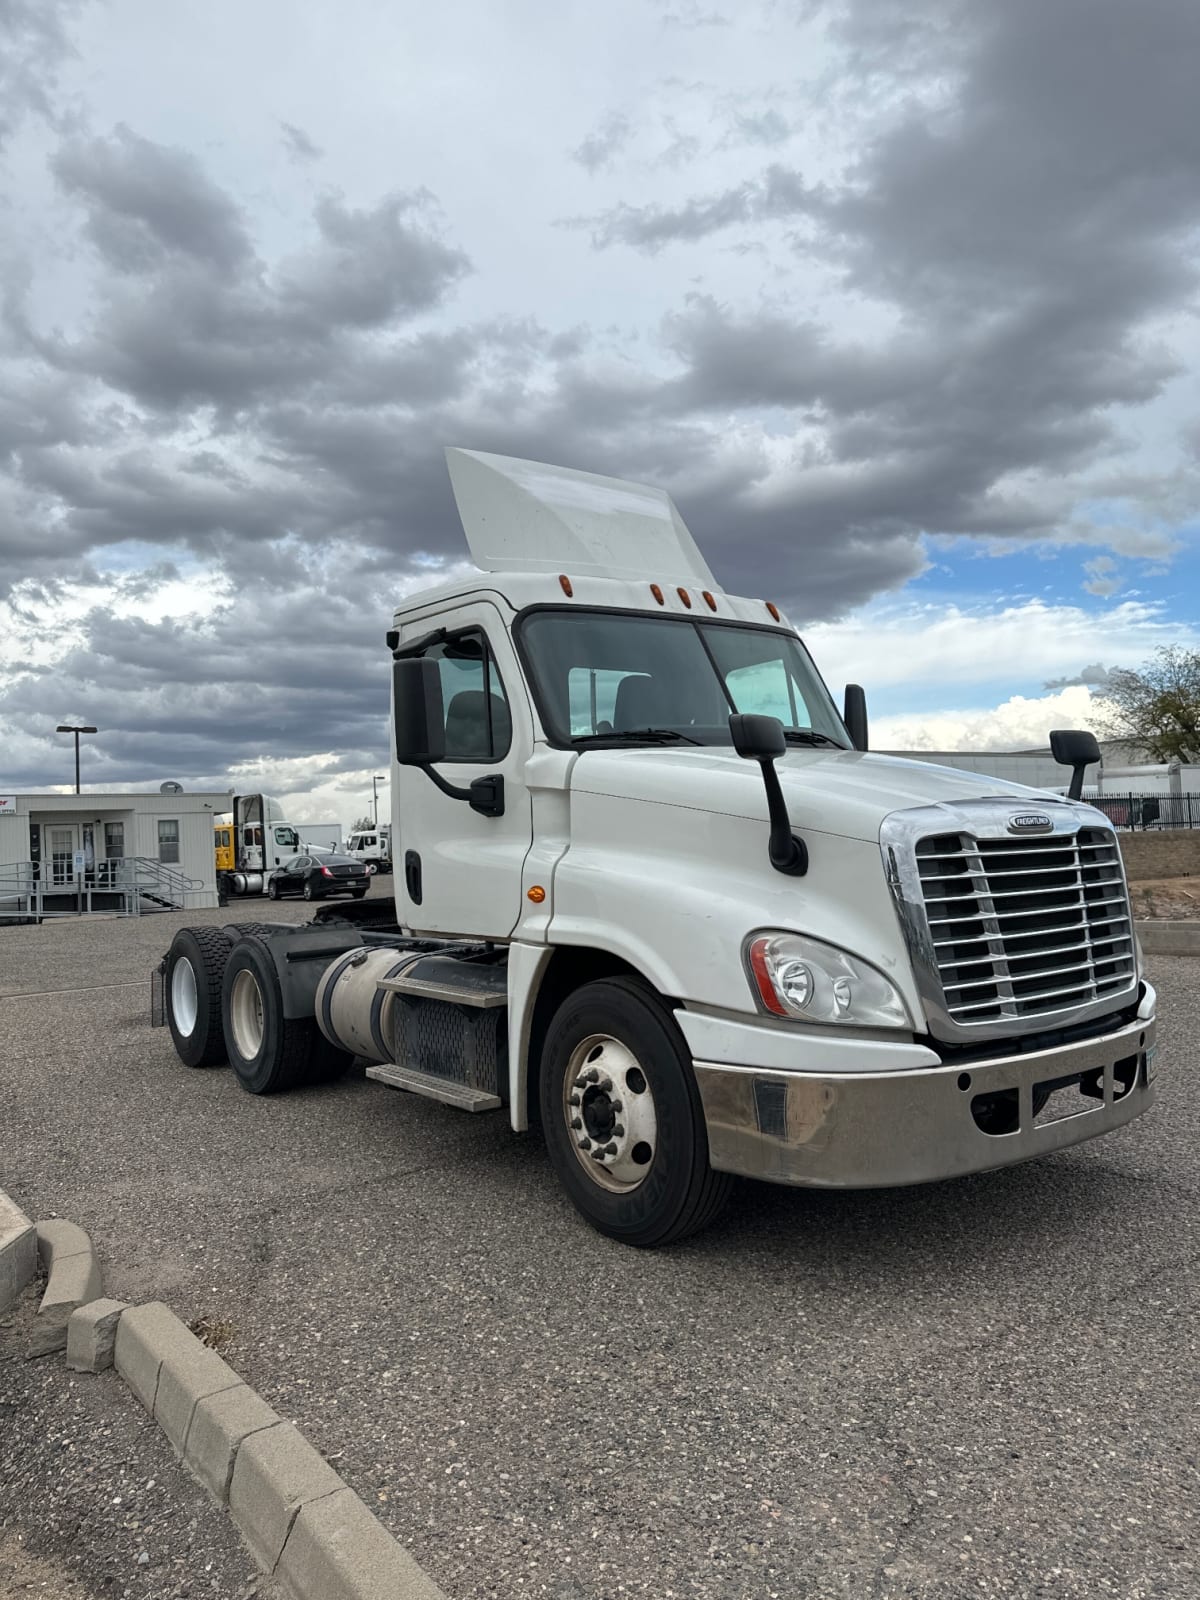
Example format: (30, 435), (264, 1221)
(539, 978), (731, 1248)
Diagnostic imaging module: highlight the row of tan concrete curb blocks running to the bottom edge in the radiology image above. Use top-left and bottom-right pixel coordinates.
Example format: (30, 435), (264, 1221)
(102, 1301), (446, 1600)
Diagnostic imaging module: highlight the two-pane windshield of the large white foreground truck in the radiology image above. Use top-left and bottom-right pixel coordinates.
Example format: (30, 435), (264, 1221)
(520, 608), (850, 747)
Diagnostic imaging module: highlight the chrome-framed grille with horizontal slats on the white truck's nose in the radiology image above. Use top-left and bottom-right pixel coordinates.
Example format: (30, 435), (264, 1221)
(915, 827), (1136, 1026)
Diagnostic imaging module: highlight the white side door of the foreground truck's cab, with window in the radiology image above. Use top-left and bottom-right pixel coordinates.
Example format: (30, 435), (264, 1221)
(392, 600), (533, 939)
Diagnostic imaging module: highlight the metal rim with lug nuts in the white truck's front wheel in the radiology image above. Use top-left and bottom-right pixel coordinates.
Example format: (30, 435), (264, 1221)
(563, 1034), (658, 1194)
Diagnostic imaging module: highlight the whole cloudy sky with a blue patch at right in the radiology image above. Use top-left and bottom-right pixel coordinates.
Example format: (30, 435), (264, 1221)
(0, 0), (1200, 821)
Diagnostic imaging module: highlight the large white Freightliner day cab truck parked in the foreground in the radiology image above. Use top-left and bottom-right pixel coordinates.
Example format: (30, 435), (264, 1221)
(158, 450), (1155, 1245)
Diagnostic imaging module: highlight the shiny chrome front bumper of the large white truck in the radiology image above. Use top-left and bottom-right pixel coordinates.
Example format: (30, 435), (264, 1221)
(694, 994), (1155, 1189)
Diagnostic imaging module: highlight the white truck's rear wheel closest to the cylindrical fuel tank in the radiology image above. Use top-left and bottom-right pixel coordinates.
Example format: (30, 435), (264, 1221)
(221, 938), (330, 1094)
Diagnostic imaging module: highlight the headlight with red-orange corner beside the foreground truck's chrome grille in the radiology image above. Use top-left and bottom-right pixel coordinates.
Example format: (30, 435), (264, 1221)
(747, 933), (914, 1029)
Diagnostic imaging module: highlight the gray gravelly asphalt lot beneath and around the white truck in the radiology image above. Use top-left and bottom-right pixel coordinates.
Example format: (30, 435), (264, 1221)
(0, 882), (1200, 1600)
